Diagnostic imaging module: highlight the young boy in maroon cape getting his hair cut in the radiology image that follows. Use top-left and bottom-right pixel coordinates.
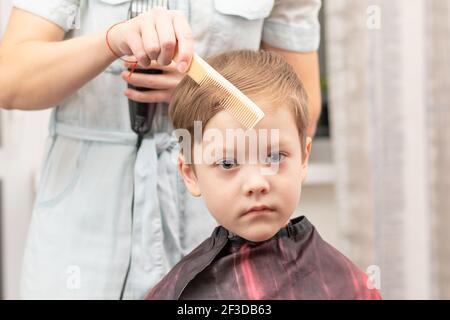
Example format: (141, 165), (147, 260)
(146, 51), (380, 299)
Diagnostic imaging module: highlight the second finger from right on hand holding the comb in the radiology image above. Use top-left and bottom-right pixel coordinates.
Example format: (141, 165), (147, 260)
(154, 8), (177, 65)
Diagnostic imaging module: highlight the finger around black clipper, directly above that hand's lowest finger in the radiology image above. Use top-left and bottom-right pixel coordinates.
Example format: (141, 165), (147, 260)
(121, 71), (182, 89)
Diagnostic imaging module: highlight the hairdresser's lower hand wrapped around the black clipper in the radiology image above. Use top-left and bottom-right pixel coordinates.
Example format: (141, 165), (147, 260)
(121, 58), (184, 103)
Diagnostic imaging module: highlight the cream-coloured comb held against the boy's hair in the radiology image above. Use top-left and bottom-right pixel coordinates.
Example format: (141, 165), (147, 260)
(187, 53), (264, 129)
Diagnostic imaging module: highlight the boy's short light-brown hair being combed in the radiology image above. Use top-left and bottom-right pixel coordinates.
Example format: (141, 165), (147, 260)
(169, 50), (309, 151)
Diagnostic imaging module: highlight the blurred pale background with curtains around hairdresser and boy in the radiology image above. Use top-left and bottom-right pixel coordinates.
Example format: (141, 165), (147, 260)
(0, 0), (450, 299)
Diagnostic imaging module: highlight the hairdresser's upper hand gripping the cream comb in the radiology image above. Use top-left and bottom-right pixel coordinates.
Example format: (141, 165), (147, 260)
(108, 8), (194, 72)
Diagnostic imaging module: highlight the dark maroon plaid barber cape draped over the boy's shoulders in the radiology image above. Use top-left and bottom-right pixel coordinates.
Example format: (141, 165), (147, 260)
(146, 217), (381, 299)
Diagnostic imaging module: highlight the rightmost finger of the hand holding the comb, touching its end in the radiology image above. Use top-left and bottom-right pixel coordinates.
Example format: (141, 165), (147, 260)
(172, 11), (194, 73)
